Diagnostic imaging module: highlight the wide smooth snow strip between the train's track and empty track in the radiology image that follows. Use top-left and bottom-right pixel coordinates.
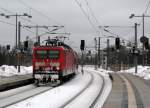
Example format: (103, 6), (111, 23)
(8, 73), (91, 108)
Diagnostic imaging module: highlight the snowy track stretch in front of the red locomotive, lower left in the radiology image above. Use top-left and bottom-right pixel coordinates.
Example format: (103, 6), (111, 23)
(0, 85), (53, 108)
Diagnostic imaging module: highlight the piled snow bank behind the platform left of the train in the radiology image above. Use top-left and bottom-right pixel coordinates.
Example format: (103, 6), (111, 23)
(0, 65), (32, 77)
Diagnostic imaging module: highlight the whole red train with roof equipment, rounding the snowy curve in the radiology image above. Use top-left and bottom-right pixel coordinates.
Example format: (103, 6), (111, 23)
(32, 39), (78, 85)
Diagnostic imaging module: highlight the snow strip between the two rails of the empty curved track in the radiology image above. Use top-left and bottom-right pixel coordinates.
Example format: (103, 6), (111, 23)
(65, 71), (103, 108)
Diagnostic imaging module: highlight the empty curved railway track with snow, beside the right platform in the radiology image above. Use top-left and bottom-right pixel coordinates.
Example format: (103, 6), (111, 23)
(61, 72), (105, 108)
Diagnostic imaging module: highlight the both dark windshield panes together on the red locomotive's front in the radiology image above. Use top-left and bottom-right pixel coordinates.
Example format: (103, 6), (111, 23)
(36, 50), (59, 59)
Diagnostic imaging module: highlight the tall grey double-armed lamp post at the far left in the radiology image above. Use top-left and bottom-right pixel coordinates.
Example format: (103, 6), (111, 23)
(0, 13), (32, 48)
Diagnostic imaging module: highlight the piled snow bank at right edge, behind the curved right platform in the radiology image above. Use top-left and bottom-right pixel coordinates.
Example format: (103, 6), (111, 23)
(119, 66), (150, 80)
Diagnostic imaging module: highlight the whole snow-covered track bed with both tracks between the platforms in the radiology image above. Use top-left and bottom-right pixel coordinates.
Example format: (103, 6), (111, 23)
(0, 70), (111, 108)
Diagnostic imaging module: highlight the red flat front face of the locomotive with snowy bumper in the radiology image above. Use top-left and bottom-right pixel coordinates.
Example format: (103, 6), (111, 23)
(32, 47), (64, 84)
